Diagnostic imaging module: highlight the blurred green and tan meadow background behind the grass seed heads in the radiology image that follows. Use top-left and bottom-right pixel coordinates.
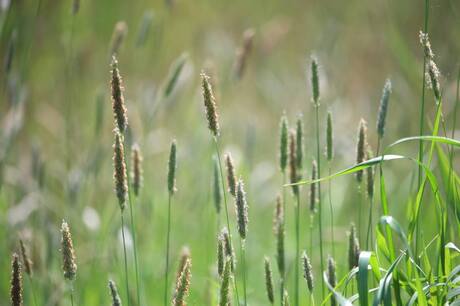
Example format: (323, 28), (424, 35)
(0, 0), (460, 305)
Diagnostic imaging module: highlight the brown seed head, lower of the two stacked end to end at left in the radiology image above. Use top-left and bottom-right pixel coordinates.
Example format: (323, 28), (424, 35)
(113, 128), (128, 210)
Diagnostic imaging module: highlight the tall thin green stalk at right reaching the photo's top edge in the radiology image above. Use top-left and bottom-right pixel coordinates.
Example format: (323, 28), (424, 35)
(415, 0), (430, 260)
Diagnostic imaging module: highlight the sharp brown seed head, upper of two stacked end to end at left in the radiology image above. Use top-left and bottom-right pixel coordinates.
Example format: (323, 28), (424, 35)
(111, 56), (128, 134)
